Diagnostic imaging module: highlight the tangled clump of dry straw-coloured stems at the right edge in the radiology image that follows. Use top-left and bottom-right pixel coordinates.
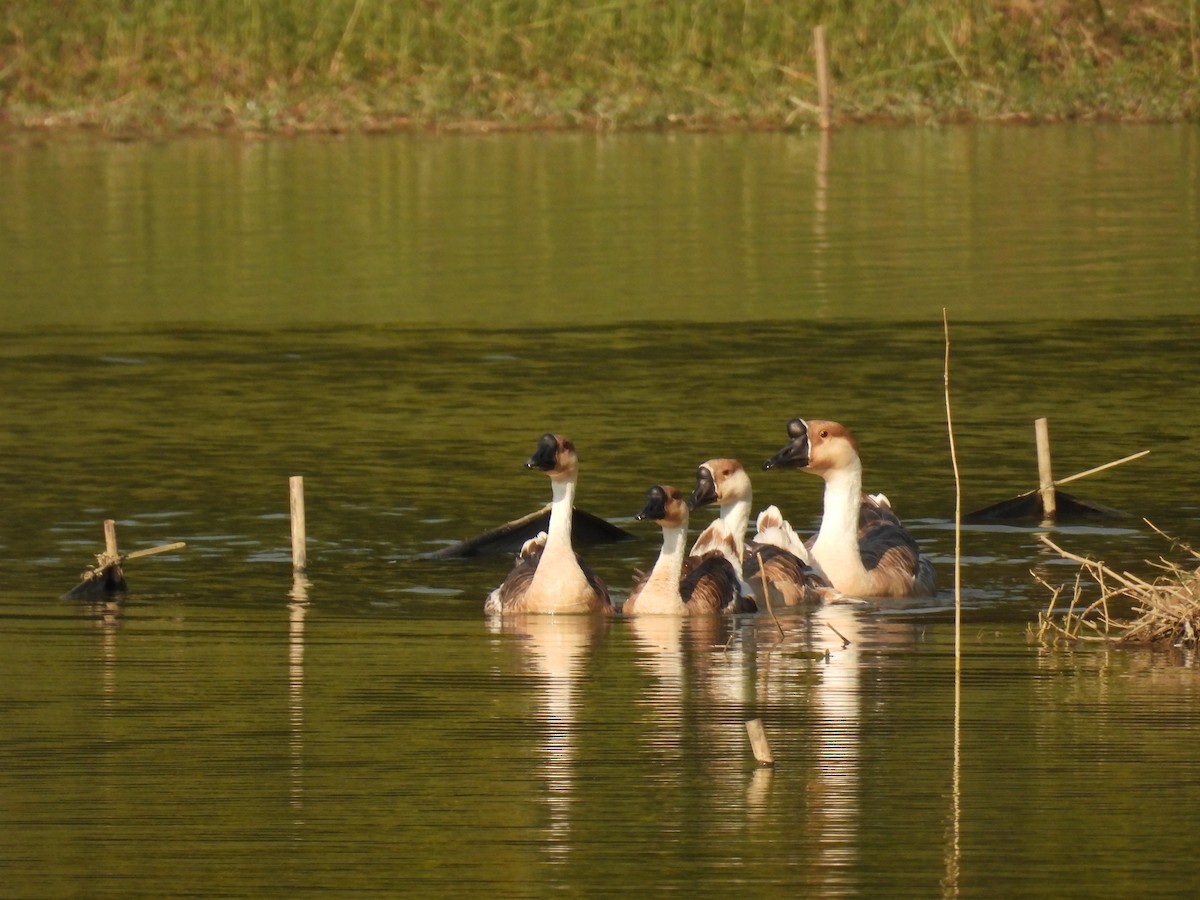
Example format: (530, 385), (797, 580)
(1030, 521), (1200, 647)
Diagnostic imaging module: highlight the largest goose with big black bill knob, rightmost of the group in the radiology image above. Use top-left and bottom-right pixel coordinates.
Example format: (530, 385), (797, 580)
(762, 419), (937, 598)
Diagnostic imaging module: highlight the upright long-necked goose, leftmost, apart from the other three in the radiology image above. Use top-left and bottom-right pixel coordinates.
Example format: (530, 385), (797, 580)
(484, 434), (613, 616)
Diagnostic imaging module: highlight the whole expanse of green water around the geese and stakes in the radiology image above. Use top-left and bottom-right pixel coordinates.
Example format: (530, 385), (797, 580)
(0, 128), (1200, 898)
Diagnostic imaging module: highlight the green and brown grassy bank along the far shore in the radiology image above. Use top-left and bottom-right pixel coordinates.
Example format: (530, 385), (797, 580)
(7, 0), (1200, 133)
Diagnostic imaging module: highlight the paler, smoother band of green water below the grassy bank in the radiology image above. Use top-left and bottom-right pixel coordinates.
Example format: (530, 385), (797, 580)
(0, 126), (1200, 328)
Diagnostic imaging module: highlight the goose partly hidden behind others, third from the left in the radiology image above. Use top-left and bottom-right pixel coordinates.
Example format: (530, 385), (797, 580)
(688, 458), (829, 606)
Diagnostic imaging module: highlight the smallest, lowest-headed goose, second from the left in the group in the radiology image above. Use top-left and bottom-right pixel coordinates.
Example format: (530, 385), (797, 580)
(622, 485), (743, 616)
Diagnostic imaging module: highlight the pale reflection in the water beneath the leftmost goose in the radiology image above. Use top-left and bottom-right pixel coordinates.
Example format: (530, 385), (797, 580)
(491, 613), (610, 862)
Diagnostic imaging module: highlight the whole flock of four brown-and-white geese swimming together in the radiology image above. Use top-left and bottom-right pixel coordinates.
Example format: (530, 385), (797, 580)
(484, 419), (936, 616)
